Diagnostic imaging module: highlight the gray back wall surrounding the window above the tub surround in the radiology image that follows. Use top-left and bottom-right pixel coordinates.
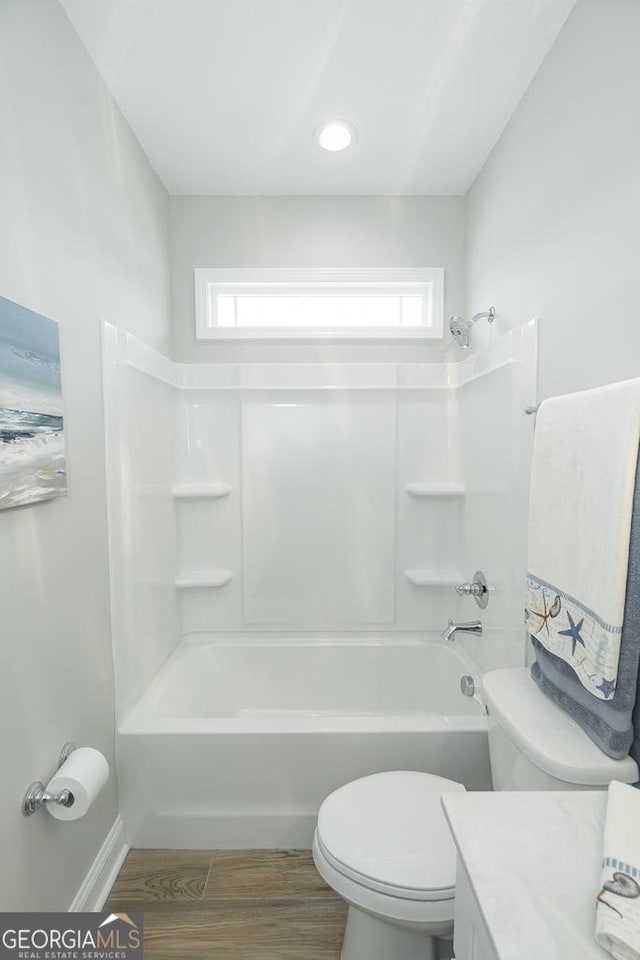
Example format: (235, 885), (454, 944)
(171, 197), (465, 363)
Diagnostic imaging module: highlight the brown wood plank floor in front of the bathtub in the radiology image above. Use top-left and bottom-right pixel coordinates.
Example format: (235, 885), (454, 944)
(105, 850), (347, 960)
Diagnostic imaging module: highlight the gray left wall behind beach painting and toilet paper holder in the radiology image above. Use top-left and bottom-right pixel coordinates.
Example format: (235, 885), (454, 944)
(0, 0), (170, 910)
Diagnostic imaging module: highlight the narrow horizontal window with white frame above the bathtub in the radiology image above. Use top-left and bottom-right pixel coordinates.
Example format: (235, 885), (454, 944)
(195, 268), (444, 339)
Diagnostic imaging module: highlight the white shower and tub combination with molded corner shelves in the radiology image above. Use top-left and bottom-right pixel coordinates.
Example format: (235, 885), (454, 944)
(104, 318), (536, 848)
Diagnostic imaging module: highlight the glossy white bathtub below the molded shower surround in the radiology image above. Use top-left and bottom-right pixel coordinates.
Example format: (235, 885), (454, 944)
(118, 639), (491, 849)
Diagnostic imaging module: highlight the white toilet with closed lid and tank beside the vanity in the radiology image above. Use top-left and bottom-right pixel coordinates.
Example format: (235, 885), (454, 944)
(313, 668), (639, 960)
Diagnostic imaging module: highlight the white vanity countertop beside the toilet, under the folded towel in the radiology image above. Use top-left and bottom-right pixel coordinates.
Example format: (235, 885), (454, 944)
(442, 790), (611, 960)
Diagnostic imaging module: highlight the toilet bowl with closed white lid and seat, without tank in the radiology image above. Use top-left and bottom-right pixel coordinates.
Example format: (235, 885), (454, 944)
(313, 770), (465, 960)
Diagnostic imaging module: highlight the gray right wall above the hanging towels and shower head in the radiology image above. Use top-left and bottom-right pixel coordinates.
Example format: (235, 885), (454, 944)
(467, 0), (640, 398)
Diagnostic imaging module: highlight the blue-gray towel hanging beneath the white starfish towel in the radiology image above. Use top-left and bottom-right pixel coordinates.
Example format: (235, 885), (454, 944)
(531, 444), (640, 766)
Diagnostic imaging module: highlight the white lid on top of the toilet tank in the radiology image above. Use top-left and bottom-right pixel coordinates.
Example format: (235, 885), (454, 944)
(482, 667), (638, 787)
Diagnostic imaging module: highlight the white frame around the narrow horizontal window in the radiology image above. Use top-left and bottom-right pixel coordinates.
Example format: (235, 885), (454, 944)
(194, 267), (444, 340)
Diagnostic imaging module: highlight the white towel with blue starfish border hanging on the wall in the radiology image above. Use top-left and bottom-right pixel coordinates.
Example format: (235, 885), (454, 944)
(526, 379), (640, 700)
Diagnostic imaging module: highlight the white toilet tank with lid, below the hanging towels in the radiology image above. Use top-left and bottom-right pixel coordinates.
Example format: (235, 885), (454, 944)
(482, 667), (639, 790)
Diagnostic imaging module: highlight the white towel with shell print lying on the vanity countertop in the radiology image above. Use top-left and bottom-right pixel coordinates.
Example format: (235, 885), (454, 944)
(596, 780), (640, 960)
